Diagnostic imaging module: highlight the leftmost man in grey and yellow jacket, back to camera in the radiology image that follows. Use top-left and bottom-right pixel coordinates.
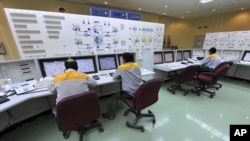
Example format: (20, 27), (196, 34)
(48, 59), (92, 102)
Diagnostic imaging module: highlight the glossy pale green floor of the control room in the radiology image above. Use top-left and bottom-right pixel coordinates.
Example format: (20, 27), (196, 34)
(0, 79), (250, 141)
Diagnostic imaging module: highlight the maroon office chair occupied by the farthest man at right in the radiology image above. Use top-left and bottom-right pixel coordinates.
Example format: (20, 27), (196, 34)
(191, 64), (230, 98)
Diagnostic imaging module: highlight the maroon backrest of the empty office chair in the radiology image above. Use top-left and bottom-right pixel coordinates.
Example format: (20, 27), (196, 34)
(179, 65), (200, 83)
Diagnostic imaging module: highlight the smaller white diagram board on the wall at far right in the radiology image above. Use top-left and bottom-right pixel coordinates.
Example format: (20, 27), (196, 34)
(203, 30), (250, 50)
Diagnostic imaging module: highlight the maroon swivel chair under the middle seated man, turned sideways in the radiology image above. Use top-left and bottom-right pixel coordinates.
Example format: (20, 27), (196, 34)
(120, 78), (164, 132)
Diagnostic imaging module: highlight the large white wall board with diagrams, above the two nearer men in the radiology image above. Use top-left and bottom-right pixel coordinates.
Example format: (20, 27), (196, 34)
(5, 8), (165, 59)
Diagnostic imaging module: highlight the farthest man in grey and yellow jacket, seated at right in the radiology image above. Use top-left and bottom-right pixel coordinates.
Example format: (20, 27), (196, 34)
(197, 47), (222, 69)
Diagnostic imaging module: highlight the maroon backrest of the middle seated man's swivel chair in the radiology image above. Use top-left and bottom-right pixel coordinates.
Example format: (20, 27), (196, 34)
(134, 78), (164, 110)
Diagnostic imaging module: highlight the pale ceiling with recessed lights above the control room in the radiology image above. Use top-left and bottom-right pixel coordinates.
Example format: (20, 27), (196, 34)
(59, 0), (250, 19)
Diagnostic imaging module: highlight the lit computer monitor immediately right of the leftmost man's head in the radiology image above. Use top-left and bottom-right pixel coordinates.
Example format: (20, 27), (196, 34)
(72, 56), (97, 74)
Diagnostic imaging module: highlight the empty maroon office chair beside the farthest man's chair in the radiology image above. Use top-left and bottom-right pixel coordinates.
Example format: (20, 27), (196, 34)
(167, 65), (200, 95)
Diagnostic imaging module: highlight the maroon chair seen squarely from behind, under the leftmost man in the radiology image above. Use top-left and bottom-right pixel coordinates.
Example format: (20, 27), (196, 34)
(56, 91), (104, 141)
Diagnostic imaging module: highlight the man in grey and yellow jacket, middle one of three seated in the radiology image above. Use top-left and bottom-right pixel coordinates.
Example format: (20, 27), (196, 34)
(102, 53), (142, 120)
